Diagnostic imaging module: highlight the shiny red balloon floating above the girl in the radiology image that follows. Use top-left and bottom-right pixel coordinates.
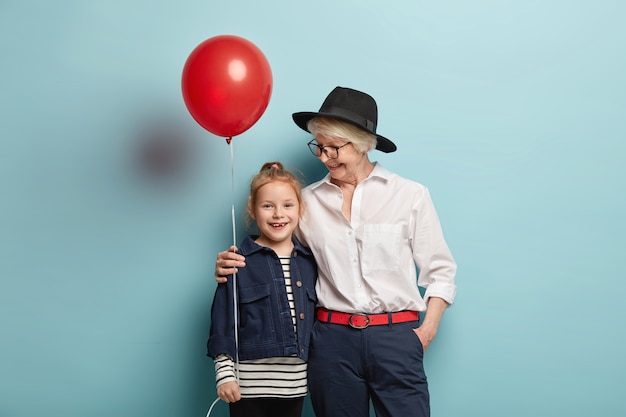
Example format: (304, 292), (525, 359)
(182, 35), (272, 138)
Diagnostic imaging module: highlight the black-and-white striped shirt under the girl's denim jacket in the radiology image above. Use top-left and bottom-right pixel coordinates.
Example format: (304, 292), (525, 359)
(215, 257), (307, 398)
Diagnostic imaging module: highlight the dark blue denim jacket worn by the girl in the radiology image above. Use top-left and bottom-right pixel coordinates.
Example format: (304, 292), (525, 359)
(207, 236), (317, 361)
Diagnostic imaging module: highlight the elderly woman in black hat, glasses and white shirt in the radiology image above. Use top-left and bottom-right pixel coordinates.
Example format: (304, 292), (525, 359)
(216, 87), (456, 417)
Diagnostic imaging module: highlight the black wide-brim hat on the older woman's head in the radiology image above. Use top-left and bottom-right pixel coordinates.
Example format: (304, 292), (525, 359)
(292, 87), (397, 153)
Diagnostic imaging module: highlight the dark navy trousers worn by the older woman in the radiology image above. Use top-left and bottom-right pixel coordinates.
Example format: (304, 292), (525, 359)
(308, 321), (430, 417)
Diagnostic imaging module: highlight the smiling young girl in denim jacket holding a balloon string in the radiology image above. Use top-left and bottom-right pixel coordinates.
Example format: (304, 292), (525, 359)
(207, 162), (317, 417)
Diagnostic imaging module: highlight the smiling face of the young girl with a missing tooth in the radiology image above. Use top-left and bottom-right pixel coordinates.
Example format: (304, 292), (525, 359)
(250, 181), (300, 253)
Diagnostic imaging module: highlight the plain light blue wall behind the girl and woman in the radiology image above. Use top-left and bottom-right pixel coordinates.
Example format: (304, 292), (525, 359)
(0, 0), (626, 417)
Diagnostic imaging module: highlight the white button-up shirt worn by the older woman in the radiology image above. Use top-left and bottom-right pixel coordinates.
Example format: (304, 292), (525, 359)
(298, 163), (456, 313)
